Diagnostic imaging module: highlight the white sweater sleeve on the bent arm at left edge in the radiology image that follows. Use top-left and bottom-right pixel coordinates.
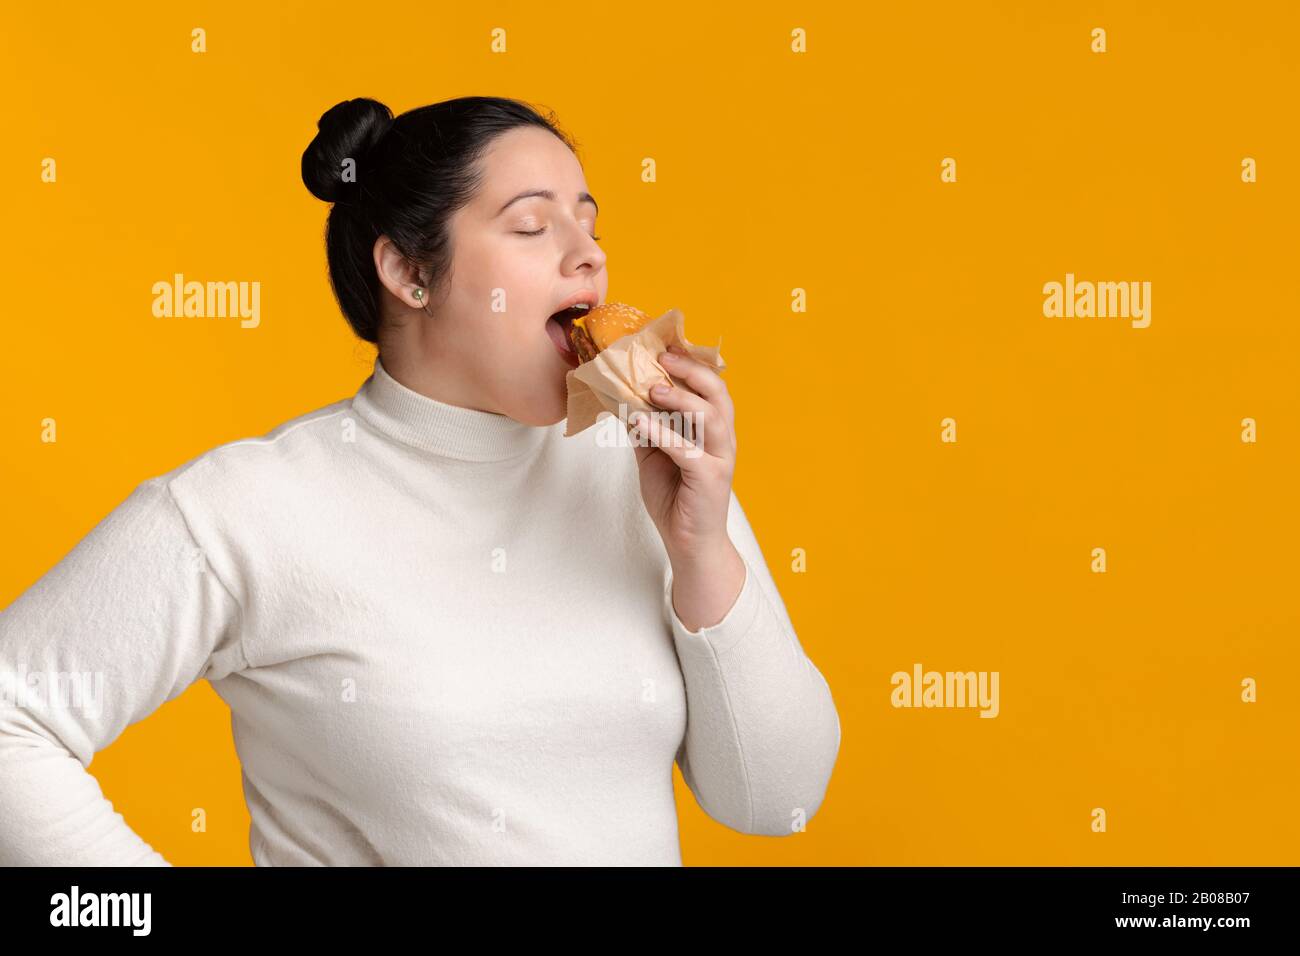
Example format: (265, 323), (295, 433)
(0, 477), (247, 866)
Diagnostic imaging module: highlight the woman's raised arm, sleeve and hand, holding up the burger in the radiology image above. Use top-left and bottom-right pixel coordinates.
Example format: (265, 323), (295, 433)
(628, 345), (840, 836)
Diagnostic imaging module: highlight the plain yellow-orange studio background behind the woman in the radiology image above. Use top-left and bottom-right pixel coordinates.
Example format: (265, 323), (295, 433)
(0, 3), (1300, 865)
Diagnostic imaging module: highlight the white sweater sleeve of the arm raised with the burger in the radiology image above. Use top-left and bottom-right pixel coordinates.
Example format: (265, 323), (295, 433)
(663, 492), (840, 836)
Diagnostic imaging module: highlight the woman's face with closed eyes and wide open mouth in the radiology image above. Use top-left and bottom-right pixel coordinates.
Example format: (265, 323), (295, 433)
(384, 126), (610, 425)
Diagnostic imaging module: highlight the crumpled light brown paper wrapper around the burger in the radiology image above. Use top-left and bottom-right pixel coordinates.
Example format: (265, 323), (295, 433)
(564, 308), (727, 438)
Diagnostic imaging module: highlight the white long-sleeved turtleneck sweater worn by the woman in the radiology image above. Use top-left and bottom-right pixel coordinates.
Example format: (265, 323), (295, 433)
(0, 360), (840, 866)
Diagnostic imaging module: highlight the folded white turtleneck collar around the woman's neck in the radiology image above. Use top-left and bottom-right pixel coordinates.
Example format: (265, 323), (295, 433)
(352, 356), (554, 462)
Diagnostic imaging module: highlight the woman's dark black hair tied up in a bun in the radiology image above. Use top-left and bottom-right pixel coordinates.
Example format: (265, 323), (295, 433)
(303, 96), (577, 342)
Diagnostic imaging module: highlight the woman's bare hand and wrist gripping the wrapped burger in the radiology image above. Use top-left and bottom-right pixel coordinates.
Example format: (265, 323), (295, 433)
(628, 346), (745, 631)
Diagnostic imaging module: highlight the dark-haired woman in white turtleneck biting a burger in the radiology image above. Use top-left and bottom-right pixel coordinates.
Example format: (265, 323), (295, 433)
(0, 96), (840, 866)
